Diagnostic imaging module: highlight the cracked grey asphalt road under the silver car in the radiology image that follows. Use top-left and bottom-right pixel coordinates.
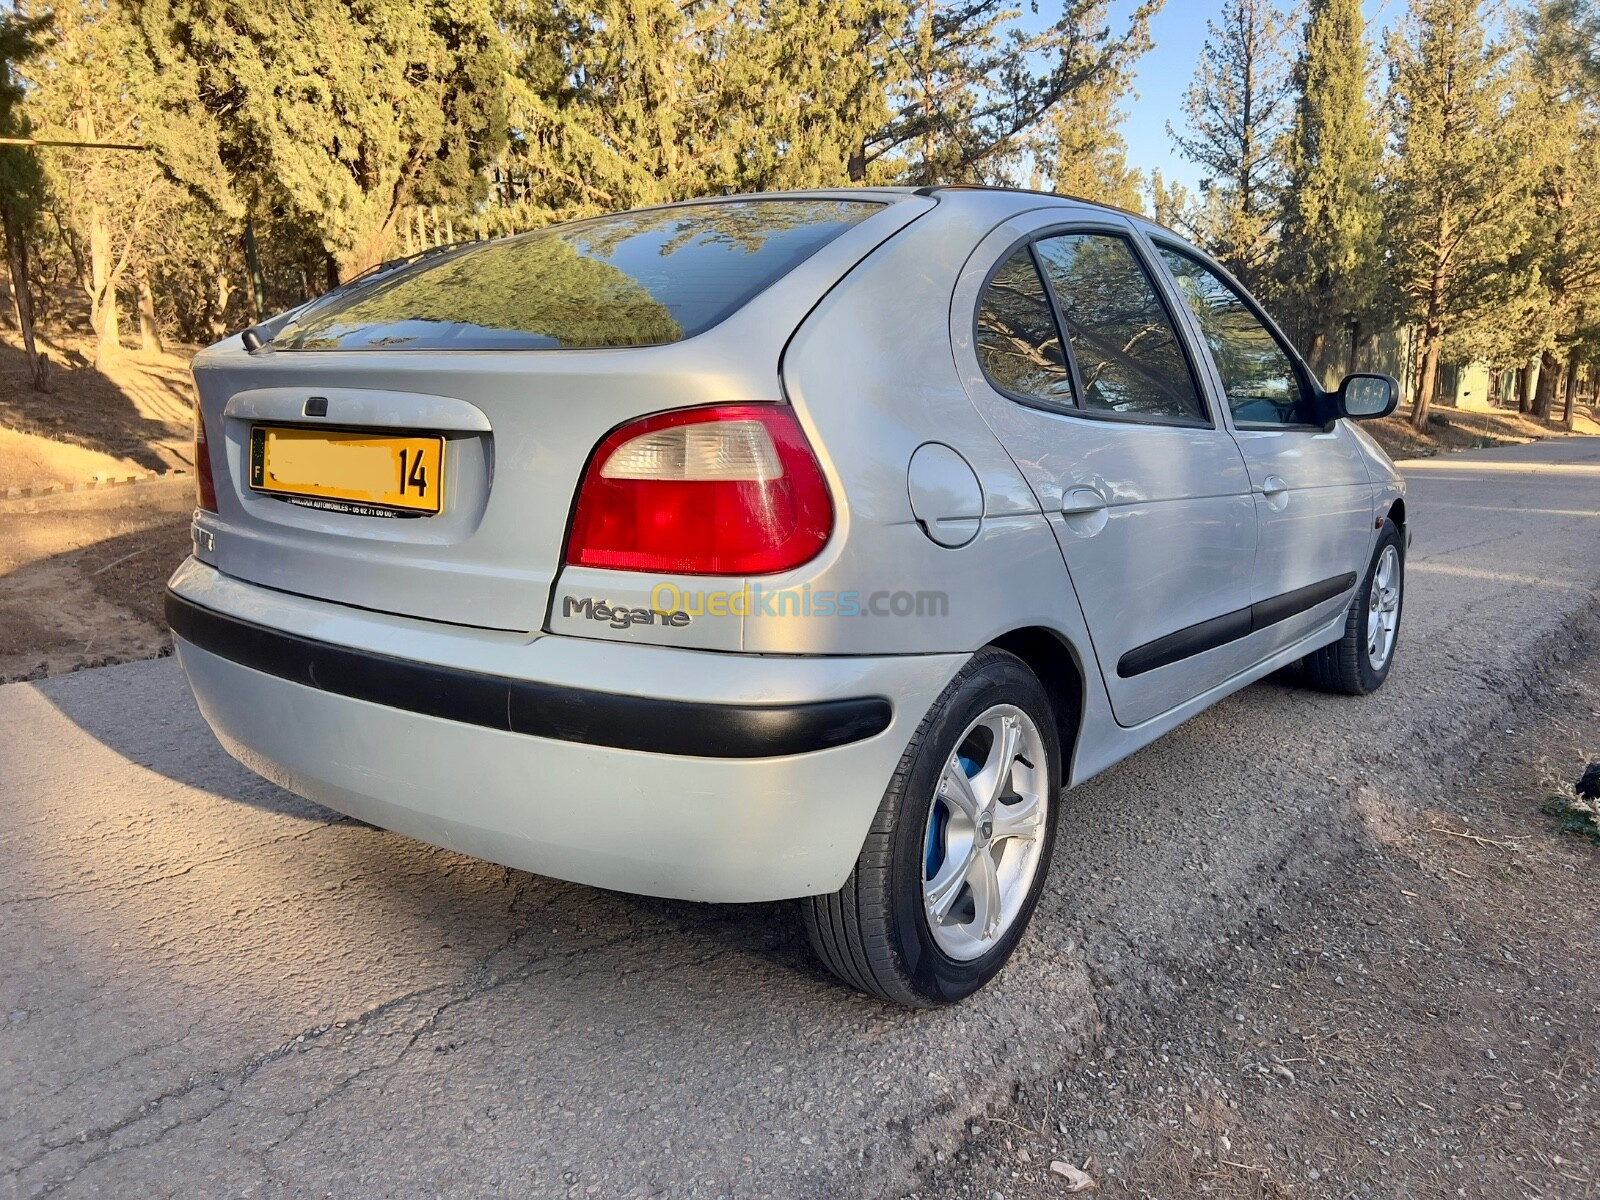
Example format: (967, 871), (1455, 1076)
(0, 438), (1600, 1197)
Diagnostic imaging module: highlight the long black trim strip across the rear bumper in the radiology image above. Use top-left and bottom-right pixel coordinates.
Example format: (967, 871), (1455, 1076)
(166, 590), (893, 758)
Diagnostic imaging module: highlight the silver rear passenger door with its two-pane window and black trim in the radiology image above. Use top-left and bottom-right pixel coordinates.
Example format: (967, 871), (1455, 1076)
(952, 210), (1256, 725)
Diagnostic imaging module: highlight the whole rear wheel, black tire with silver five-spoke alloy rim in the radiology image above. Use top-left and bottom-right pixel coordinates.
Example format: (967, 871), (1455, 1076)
(803, 650), (1061, 1005)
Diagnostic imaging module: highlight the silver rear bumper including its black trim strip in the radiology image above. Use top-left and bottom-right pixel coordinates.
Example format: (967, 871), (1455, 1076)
(168, 560), (966, 901)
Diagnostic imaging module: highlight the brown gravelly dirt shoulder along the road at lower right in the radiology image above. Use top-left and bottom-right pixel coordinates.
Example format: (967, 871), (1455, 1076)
(918, 640), (1600, 1200)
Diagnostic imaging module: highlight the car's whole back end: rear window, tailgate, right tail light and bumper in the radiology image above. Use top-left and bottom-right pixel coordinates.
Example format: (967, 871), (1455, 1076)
(168, 192), (962, 901)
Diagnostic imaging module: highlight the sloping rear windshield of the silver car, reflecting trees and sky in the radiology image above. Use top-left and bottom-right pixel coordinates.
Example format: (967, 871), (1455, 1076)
(272, 198), (883, 350)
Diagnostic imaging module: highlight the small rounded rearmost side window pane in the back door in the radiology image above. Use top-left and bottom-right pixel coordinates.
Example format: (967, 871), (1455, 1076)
(978, 246), (1074, 408)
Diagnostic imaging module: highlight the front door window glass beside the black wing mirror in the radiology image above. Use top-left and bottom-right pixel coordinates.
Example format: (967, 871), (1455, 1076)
(1157, 246), (1314, 424)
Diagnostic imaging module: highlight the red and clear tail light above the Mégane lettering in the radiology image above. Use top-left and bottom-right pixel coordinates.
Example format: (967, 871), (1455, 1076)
(566, 405), (834, 574)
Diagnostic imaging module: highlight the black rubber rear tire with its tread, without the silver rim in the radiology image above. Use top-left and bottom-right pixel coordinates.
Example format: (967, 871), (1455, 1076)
(802, 650), (1061, 1008)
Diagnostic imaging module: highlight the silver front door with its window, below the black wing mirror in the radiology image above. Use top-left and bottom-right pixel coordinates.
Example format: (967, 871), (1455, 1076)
(1150, 237), (1373, 656)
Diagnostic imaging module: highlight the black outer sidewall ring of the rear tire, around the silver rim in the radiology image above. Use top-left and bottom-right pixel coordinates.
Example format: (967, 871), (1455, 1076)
(890, 654), (1061, 1003)
